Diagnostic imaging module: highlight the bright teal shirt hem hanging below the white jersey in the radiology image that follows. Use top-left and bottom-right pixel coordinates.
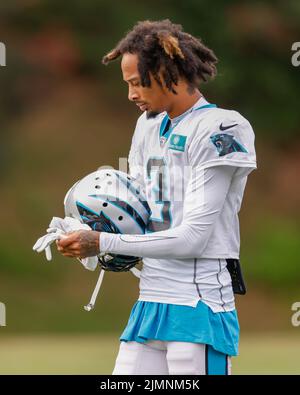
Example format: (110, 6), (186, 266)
(120, 301), (239, 356)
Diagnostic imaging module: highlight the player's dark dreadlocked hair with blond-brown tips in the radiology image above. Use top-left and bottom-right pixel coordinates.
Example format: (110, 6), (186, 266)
(102, 19), (218, 94)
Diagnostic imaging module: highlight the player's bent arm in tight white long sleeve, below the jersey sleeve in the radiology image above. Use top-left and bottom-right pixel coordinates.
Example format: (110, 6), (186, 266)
(100, 166), (236, 259)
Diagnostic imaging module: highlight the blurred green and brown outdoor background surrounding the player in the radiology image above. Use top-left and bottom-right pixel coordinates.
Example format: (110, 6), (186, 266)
(0, 0), (300, 373)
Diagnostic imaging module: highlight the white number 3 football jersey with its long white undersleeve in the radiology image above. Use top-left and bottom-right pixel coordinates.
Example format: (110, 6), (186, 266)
(100, 98), (256, 312)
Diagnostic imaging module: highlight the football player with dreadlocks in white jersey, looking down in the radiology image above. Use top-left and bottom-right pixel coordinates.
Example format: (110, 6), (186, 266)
(58, 20), (256, 375)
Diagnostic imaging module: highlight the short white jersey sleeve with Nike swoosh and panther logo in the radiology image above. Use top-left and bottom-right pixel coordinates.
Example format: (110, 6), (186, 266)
(188, 111), (257, 174)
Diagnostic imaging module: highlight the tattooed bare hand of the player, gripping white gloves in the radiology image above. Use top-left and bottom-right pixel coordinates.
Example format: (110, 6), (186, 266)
(56, 230), (100, 259)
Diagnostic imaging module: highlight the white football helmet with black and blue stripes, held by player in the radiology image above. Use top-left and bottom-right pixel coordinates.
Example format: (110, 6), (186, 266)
(64, 169), (151, 271)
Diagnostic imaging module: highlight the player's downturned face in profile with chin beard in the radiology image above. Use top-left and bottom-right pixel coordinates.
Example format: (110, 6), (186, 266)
(121, 53), (170, 118)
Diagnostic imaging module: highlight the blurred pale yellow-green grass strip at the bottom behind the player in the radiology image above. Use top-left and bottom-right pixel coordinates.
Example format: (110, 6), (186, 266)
(0, 333), (300, 374)
